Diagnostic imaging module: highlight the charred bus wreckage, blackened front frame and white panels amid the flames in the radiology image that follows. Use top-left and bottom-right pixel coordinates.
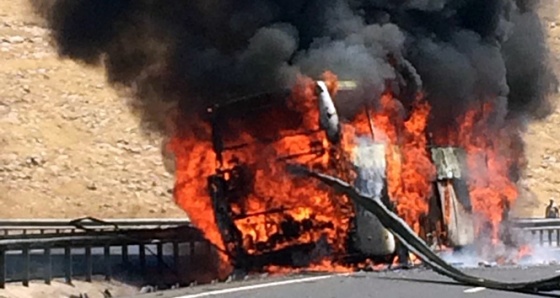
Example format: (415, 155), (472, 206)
(203, 77), (484, 272)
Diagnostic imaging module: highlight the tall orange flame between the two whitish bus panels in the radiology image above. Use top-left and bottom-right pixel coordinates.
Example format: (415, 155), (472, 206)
(345, 92), (435, 233)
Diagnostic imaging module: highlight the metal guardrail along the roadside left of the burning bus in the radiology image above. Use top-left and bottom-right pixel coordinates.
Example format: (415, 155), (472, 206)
(0, 218), (212, 288)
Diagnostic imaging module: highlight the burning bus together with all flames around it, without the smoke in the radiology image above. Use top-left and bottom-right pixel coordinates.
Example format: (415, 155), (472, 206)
(170, 73), (526, 273)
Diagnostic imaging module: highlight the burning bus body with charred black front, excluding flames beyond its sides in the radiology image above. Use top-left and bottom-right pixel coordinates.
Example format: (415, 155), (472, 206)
(200, 77), (482, 271)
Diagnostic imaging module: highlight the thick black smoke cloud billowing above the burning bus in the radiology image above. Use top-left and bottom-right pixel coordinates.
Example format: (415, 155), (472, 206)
(31, 0), (556, 131)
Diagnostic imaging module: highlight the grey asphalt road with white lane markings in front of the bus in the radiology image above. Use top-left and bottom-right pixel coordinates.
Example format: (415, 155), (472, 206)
(128, 266), (560, 298)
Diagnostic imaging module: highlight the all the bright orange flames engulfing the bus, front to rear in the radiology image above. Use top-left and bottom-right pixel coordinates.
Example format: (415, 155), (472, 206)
(170, 72), (517, 272)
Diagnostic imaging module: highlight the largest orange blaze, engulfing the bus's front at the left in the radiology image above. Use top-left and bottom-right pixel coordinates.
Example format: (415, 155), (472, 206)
(170, 73), (352, 270)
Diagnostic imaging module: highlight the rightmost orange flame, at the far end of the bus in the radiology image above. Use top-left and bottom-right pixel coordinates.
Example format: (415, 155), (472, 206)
(438, 101), (519, 242)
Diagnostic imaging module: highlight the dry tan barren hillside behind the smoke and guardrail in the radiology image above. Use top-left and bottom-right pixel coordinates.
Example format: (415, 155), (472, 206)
(0, 0), (560, 218)
